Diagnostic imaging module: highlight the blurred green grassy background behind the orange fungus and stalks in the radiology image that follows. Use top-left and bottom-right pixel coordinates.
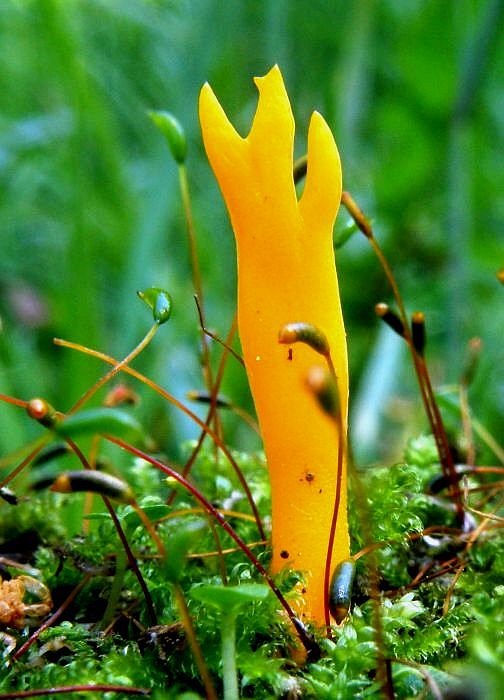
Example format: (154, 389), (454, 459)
(0, 0), (504, 462)
